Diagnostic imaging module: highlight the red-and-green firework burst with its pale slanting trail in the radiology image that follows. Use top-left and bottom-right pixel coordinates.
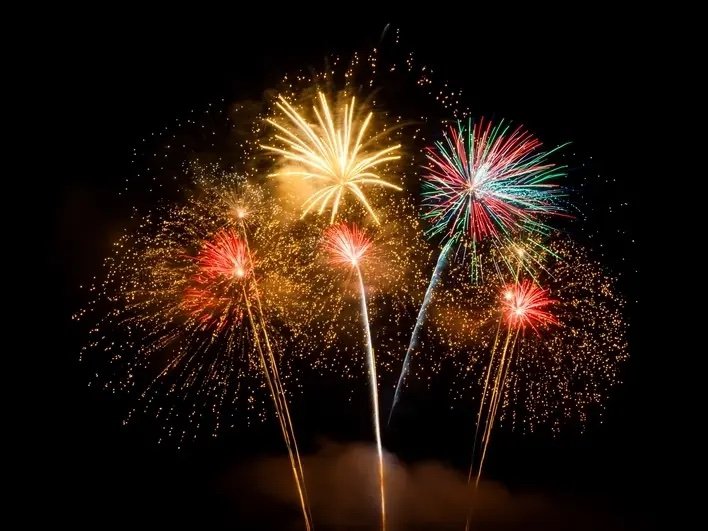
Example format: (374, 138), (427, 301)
(389, 120), (563, 422)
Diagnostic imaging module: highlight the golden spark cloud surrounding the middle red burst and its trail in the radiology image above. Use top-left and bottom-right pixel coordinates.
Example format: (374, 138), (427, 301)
(258, 190), (430, 382)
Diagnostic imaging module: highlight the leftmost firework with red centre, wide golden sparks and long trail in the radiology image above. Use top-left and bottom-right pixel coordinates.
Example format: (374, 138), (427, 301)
(76, 175), (311, 529)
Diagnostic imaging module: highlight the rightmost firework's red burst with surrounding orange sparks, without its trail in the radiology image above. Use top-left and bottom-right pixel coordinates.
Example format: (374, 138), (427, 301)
(442, 237), (627, 432)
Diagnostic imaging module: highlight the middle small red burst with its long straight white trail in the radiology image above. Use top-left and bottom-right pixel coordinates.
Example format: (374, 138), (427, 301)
(325, 224), (386, 530)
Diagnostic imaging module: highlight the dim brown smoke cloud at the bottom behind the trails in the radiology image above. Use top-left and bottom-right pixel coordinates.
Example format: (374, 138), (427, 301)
(220, 443), (625, 531)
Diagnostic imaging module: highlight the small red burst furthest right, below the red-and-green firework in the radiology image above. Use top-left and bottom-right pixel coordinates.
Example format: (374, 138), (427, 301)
(502, 280), (558, 331)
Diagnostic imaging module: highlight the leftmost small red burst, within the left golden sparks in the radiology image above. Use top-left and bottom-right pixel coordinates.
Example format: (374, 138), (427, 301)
(197, 229), (251, 280)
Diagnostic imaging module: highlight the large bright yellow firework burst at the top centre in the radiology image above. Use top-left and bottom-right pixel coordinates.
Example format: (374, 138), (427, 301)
(263, 92), (401, 223)
